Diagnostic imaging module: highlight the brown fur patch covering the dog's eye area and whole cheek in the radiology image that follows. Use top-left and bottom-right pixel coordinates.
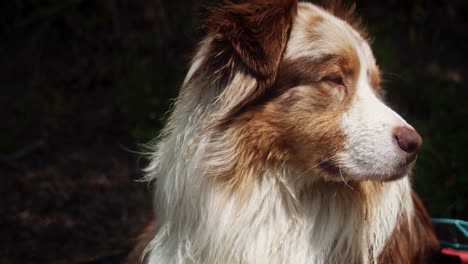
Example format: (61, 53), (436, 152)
(215, 53), (358, 189)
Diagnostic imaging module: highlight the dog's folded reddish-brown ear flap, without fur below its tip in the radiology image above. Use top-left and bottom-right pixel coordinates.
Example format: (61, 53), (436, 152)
(208, 0), (297, 78)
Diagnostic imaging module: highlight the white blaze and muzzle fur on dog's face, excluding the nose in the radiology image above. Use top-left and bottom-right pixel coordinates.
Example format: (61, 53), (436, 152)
(338, 38), (411, 180)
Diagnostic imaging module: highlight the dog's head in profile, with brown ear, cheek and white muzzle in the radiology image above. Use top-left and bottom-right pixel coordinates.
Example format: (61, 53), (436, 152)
(185, 0), (422, 185)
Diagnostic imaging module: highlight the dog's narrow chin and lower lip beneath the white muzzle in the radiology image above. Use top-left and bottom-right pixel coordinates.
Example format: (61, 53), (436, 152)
(320, 161), (414, 183)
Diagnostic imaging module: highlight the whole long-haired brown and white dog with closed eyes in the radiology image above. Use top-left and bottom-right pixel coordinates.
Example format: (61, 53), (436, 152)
(134, 0), (438, 264)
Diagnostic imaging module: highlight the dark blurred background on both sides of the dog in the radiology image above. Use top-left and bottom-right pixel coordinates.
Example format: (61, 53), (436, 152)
(0, 0), (468, 263)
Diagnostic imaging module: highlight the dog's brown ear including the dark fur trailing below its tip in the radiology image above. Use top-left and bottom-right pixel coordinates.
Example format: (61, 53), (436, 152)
(206, 0), (298, 121)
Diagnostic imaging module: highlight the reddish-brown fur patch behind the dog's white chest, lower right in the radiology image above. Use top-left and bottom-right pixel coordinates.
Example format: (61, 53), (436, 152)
(378, 191), (439, 264)
